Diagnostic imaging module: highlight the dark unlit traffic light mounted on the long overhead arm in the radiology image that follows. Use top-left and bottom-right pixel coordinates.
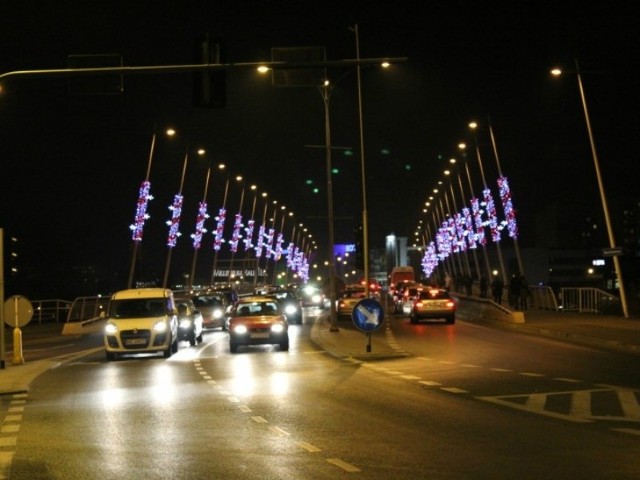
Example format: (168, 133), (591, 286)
(193, 34), (226, 108)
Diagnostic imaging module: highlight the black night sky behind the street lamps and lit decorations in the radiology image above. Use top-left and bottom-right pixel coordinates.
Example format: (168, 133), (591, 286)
(0, 1), (640, 296)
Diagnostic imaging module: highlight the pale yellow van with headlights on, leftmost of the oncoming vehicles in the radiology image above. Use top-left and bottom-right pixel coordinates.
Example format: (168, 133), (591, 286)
(104, 288), (178, 360)
